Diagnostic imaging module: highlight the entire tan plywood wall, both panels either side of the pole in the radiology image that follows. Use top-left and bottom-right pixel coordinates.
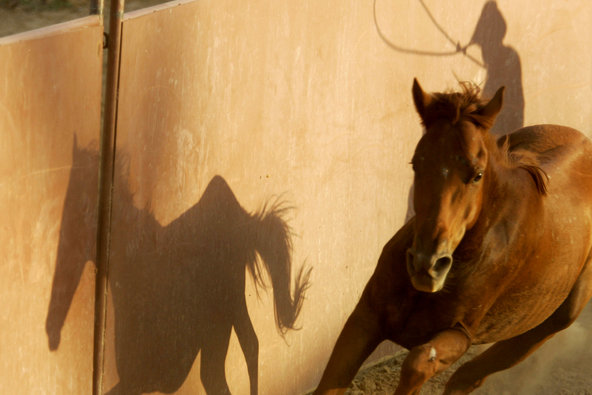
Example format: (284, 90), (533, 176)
(0, 0), (592, 394)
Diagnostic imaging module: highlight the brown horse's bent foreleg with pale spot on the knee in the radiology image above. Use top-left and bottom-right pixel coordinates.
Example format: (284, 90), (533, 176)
(395, 329), (471, 395)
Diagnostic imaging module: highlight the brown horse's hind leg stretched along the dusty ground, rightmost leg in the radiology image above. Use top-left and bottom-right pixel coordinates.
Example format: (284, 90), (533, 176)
(444, 261), (592, 394)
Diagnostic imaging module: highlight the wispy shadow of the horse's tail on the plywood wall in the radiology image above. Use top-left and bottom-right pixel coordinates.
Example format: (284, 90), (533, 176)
(247, 201), (312, 335)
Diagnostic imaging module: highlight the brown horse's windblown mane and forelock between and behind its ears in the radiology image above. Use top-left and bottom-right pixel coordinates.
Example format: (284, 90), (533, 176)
(422, 81), (549, 195)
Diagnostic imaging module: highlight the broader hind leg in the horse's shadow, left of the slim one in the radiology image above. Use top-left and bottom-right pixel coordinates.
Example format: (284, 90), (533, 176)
(200, 323), (232, 395)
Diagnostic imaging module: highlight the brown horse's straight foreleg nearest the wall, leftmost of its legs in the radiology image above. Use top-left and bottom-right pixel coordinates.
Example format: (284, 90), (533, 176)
(314, 298), (384, 395)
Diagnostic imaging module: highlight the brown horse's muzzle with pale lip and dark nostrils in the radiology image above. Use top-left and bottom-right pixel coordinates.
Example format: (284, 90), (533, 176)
(407, 248), (452, 292)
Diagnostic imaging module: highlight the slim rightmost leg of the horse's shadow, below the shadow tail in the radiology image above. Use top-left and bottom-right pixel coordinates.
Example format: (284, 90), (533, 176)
(234, 298), (259, 395)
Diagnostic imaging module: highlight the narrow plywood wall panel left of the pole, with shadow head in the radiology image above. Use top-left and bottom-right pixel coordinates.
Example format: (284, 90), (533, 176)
(0, 17), (102, 394)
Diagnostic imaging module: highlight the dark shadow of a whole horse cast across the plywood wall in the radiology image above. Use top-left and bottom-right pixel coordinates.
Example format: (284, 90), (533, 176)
(46, 140), (310, 395)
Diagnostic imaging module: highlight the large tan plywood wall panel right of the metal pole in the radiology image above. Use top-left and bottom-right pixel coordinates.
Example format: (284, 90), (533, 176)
(99, 0), (592, 394)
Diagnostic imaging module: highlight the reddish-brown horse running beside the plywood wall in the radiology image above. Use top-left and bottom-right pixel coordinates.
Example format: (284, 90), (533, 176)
(315, 81), (592, 394)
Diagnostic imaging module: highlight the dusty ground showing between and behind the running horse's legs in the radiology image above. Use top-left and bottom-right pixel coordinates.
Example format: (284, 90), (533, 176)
(348, 305), (592, 395)
